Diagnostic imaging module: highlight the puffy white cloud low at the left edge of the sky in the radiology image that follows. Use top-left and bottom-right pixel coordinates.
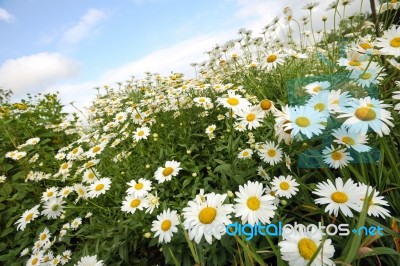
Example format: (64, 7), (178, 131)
(0, 53), (80, 97)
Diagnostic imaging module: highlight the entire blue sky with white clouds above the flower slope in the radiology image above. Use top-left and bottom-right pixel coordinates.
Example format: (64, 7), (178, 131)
(0, 0), (370, 110)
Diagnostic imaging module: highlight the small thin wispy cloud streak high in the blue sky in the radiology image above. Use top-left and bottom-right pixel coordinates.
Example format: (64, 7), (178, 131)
(63, 8), (106, 44)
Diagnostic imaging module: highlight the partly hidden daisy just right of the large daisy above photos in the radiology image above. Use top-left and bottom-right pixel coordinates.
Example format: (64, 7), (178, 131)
(359, 183), (391, 219)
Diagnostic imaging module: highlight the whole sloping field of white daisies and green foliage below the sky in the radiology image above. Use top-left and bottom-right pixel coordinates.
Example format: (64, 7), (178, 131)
(0, 0), (400, 265)
